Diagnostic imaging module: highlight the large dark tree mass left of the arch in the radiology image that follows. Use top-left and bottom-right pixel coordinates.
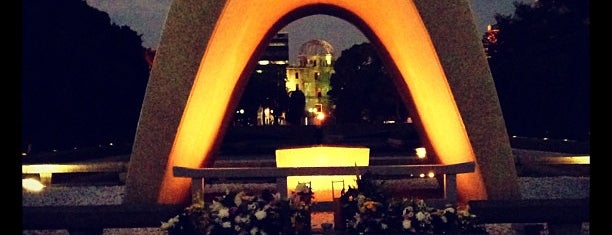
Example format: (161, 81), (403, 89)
(21, 0), (150, 151)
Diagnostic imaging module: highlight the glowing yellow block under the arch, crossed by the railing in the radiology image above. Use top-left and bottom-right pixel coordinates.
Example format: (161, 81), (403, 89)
(276, 146), (370, 202)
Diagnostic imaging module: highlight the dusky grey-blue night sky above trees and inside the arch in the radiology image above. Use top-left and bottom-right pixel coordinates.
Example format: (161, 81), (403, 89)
(87, 0), (532, 63)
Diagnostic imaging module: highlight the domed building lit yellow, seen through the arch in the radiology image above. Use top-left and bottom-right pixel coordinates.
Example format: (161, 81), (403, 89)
(286, 39), (334, 125)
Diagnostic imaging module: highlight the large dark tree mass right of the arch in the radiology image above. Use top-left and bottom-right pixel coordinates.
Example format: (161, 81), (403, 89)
(483, 0), (590, 140)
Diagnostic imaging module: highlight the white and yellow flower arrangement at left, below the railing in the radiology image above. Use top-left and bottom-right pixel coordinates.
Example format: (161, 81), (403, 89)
(161, 184), (314, 235)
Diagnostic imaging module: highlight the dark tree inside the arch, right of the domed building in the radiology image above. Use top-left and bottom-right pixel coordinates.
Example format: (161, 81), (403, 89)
(327, 43), (408, 123)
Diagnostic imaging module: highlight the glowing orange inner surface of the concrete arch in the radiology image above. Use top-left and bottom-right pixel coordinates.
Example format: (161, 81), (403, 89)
(158, 0), (486, 203)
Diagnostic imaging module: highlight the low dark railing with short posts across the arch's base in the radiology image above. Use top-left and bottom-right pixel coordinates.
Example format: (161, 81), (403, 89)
(173, 162), (475, 202)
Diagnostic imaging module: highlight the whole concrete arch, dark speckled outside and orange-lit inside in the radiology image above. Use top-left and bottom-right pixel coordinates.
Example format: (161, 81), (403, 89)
(126, 0), (518, 203)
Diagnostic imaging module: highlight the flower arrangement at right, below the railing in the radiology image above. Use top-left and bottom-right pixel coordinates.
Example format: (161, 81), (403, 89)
(340, 172), (486, 234)
